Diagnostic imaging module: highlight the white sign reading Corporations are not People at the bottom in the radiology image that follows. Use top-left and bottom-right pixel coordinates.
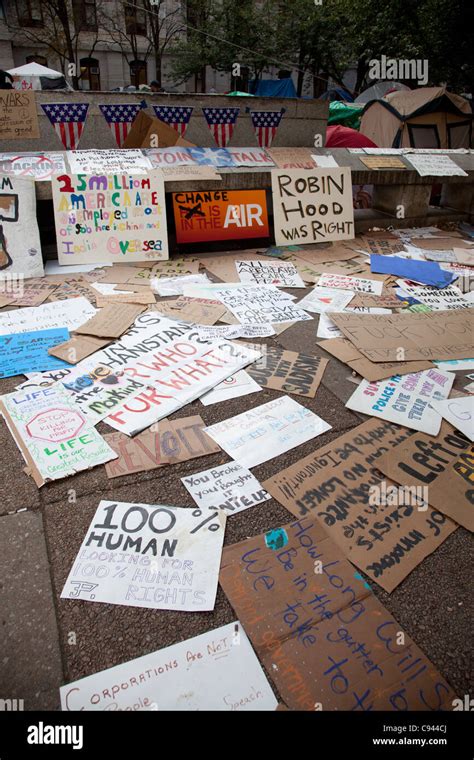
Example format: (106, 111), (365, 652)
(60, 621), (277, 712)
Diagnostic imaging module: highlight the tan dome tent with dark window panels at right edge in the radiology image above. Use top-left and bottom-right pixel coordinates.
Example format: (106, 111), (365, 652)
(360, 87), (473, 148)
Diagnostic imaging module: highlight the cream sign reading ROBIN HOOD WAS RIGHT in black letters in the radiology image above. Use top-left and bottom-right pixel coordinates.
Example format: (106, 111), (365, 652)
(271, 168), (354, 245)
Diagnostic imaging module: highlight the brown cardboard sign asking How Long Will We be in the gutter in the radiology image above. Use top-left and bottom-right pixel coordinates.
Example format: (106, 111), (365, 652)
(219, 517), (455, 712)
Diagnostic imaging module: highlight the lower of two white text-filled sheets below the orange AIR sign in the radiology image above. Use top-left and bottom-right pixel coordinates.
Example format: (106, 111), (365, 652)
(212, 285), (311, 324)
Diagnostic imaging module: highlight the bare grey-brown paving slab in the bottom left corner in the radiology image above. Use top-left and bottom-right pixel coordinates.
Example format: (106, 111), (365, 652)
(0, 512), (63, 710)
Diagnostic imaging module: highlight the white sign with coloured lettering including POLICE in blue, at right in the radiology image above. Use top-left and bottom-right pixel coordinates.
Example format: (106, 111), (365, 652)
(346, 369), (454, 435)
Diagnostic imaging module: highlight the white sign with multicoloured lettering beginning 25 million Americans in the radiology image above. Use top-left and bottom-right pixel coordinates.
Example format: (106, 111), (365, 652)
(52, 171), (168, 264)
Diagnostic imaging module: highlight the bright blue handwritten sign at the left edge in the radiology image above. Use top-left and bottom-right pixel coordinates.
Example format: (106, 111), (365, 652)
(0, 328), (69, 378)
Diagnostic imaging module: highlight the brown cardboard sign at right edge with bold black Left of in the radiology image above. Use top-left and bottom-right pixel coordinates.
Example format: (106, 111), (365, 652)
(377, 420), (474, 531)
